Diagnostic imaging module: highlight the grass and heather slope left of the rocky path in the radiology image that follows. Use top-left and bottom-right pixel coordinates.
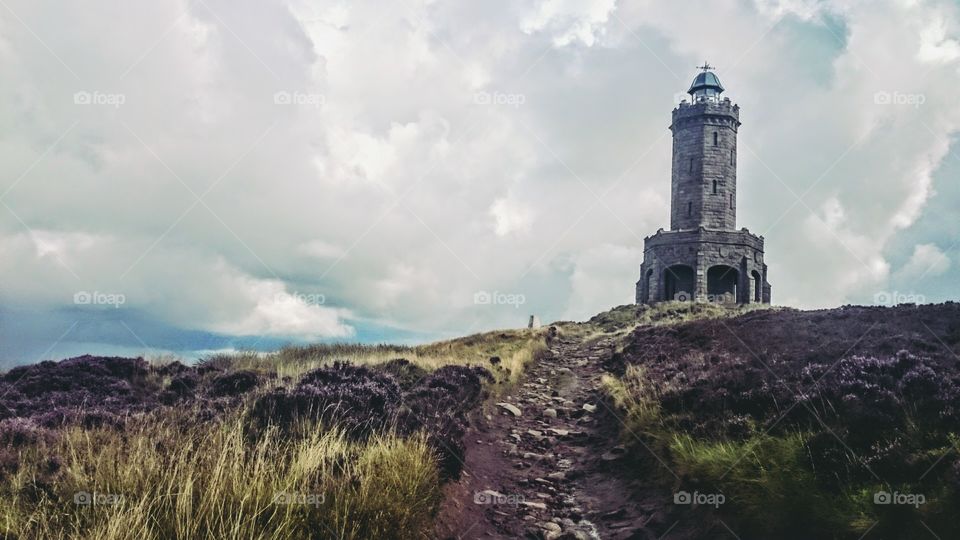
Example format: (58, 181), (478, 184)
(0, 330), (543, 540)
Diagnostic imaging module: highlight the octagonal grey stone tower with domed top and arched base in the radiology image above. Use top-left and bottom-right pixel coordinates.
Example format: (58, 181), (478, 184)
(636, 64), (770, 304)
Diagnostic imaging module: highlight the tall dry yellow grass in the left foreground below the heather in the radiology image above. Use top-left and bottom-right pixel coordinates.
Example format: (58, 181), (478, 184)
(0, 413), (440, 540)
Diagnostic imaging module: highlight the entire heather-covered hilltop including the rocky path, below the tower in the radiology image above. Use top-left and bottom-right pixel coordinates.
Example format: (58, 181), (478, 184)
(0, 303), (960, 539)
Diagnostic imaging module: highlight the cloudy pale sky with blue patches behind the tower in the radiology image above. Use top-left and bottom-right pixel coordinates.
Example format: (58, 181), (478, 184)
(0, 0), (960, 365)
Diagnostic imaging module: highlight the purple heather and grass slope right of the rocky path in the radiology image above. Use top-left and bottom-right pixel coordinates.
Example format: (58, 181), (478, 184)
(606, 303), (960, 538)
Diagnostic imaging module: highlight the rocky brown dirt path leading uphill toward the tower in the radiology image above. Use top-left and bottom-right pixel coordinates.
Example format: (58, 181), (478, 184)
(436, 338), (666, 539)
